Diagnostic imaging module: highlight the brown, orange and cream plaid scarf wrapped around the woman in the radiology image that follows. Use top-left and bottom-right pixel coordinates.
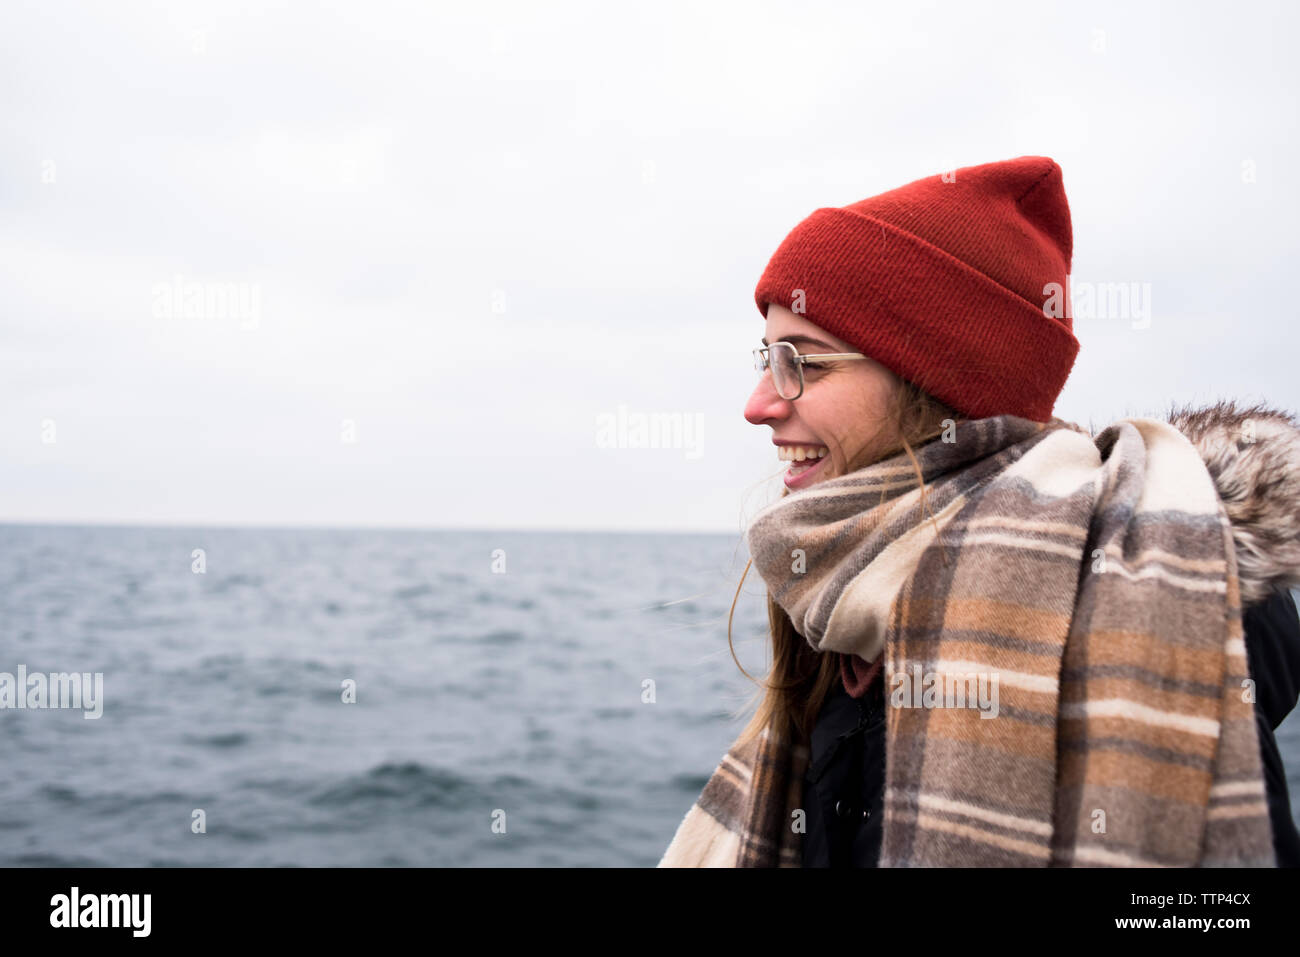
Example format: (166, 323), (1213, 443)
(659, 415), (1275, 867)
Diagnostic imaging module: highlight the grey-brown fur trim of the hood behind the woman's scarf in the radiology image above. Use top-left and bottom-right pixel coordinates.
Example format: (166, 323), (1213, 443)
(1165, 400), (1300, 606)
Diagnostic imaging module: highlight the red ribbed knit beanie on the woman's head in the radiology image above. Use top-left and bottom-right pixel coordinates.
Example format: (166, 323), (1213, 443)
(754, 156), (1079, 421)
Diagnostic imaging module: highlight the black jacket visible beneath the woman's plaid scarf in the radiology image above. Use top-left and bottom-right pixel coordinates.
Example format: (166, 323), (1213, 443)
(803, 589), (1300, 867)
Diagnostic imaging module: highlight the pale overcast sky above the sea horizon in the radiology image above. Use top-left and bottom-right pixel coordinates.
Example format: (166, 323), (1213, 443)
(0, 0), (1300, 532)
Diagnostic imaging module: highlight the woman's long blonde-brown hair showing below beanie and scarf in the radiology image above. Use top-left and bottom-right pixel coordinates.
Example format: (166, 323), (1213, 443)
(727, 380), (962, 742)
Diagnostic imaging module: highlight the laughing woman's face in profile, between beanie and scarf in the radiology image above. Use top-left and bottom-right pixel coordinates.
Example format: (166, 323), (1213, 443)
(745, 303), (902, 490)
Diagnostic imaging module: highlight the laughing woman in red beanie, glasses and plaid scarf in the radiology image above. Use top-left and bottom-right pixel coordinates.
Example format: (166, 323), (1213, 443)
(660, 156), (1300, 866)
